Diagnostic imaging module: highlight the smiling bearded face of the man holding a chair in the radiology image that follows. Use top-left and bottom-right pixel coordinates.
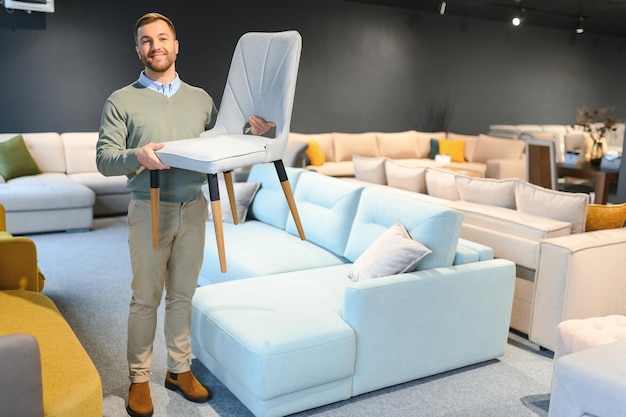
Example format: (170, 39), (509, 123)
(135, 20), (178, 73)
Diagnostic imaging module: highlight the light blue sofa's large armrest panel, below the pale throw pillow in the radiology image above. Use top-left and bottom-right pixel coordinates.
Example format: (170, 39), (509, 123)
(343, 259), (515, 395)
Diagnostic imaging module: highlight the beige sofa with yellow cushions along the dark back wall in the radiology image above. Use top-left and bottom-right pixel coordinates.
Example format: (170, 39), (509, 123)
(289, 130), (526, 178)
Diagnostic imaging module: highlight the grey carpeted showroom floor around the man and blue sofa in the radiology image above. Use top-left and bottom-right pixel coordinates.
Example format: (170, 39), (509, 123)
(30, 217), (552, 417)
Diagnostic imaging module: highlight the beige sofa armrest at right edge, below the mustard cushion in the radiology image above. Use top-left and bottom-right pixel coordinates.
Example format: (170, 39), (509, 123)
(529, 228), (626, 350)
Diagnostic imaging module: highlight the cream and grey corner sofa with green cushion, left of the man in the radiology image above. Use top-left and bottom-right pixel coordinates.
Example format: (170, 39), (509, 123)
(0, 132), (130, 234)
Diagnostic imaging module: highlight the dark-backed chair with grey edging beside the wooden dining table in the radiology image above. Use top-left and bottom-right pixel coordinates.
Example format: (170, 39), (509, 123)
(526, 138), (594, 194)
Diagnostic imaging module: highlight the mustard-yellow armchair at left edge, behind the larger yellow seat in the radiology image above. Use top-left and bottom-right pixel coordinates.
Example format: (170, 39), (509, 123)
(0, 204), (45, 291)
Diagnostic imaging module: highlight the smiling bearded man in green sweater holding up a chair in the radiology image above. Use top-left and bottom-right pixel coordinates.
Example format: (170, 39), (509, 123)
(96, 13), (273, 417)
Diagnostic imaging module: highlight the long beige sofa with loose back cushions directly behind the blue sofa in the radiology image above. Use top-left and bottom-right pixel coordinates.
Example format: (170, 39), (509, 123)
(346, 160), (626, 350)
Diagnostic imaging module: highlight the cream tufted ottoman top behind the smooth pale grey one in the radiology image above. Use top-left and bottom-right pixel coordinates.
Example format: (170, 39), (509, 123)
(554, 315), (626, 363)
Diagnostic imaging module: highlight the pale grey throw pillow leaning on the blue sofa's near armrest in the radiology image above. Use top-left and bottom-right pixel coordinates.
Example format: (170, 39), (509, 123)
(348, 223), (432, 282)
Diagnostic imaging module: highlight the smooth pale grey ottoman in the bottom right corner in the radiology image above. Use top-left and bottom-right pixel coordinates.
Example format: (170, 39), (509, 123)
(548, 339), (626, 417)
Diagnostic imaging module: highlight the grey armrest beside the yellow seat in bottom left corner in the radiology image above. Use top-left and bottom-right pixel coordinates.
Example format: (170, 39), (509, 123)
(0, 334), (44, 417)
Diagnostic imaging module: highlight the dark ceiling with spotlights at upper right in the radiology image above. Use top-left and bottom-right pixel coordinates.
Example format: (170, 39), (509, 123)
(351, 0), (626, 38)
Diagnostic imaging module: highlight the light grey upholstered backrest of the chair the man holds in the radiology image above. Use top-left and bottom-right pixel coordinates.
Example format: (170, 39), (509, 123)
(215, 31), (302, 162)
